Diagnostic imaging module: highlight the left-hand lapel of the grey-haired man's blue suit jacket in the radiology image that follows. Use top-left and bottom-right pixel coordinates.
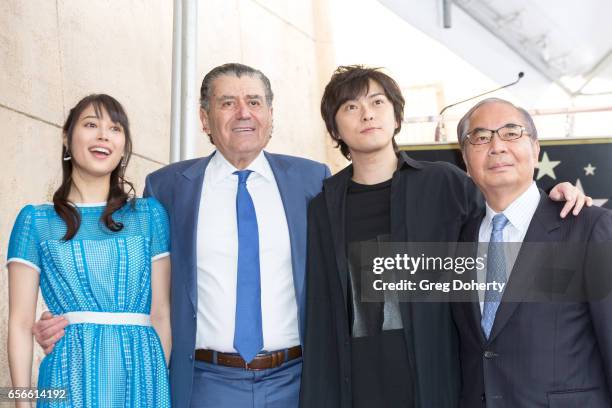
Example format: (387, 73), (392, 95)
(172, 153), (214, 311)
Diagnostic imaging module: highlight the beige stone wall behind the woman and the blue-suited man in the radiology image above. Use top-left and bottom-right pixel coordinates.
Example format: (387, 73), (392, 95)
(0, 0), (344, 386)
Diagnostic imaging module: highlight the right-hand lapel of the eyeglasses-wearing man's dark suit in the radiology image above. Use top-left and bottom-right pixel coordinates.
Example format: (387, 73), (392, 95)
(489, 191), (561, 342)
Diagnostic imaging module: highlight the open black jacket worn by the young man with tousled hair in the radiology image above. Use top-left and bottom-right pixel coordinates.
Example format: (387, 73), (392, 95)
(300, 152), (483, 408)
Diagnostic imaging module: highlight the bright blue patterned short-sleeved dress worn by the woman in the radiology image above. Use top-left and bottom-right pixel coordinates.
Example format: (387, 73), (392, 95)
(8, 198), (170, 407)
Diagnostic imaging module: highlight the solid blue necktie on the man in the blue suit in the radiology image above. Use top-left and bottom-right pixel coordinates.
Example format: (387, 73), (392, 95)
(234, 170), (263, 363)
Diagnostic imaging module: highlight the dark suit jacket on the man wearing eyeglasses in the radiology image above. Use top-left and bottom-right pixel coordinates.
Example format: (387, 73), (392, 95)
(453, 193), (612, 408)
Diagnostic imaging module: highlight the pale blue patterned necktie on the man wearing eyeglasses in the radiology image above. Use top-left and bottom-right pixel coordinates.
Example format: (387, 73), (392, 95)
(480, 213), (508, 339)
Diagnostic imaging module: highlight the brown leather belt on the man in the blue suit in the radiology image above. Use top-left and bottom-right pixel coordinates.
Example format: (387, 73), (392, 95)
(195, 346), (302, 370)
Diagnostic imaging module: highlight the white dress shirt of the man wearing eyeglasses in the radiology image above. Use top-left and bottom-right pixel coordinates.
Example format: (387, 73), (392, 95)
(478, 181), (540, 313)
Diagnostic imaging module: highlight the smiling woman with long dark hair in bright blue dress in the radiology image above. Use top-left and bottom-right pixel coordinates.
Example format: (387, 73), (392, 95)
(7, 94), (171, 407)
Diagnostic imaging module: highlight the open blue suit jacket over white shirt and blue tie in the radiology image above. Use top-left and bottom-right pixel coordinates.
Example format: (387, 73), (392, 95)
(144, 152), (330, 407)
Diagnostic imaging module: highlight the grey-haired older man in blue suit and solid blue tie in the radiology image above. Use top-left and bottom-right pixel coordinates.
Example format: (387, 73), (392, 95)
(145, 64), (330, 407)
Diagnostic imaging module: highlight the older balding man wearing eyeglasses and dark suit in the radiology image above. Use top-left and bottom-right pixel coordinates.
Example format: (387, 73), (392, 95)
(453, 99), (612, 408)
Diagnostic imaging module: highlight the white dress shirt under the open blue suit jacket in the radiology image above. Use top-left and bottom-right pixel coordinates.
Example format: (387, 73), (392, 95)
(196, 151), (300, 352)
